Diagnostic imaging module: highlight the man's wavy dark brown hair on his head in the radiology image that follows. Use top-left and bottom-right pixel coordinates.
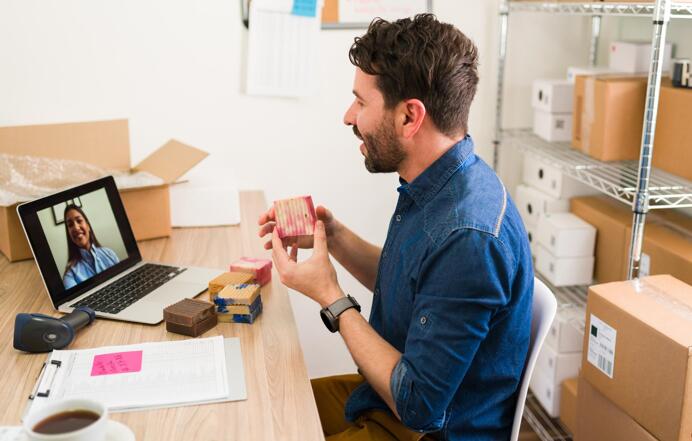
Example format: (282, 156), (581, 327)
(348, 14), (478, 136)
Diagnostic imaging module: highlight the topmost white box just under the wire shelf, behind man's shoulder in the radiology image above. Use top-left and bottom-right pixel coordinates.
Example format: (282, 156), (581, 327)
(523, 154), (598, 199)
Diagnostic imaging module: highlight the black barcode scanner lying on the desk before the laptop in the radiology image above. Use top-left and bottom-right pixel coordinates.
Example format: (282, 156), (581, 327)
(14, 306), (96, 352)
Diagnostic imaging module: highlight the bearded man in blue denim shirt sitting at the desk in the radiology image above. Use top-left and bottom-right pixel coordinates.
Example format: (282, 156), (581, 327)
(259, 14), (533, 440)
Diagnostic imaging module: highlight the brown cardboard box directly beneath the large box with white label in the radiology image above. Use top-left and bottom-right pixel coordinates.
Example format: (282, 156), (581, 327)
(573, 377), (658, 441)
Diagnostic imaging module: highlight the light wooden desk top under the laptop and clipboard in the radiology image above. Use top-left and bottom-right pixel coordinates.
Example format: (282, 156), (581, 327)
(0, 192), (324, 441)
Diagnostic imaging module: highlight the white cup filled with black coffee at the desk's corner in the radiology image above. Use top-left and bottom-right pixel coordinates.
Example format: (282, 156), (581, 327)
(23, 398), (108, 441)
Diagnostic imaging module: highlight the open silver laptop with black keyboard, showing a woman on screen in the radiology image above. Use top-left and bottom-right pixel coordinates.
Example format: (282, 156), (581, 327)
(17, 176), (222, 324)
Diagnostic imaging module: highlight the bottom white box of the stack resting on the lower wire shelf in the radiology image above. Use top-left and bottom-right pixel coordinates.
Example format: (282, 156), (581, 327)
(536, 244), (594, 287)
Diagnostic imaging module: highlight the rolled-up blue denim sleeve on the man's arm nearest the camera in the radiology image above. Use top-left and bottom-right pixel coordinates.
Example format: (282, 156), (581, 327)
(390, 229), (514, 432)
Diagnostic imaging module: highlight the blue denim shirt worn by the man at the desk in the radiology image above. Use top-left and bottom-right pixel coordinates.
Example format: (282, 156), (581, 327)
(345, 136), (533, 441)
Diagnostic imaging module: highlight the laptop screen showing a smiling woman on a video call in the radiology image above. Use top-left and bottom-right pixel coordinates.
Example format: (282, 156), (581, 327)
(18, 177), (141, 307)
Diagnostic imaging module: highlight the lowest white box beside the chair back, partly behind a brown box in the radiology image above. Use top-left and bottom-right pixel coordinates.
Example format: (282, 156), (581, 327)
(529, 345), (581, 418)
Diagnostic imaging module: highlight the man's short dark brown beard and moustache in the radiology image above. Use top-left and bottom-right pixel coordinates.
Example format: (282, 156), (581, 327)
(353, 119), (406, 173)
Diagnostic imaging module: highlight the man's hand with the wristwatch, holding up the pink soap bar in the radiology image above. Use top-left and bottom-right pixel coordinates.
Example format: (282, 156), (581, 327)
(272, 221), (344, 308)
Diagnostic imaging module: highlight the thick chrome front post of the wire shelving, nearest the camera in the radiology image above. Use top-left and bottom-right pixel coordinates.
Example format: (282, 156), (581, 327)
(627, 0), (671, 279)
